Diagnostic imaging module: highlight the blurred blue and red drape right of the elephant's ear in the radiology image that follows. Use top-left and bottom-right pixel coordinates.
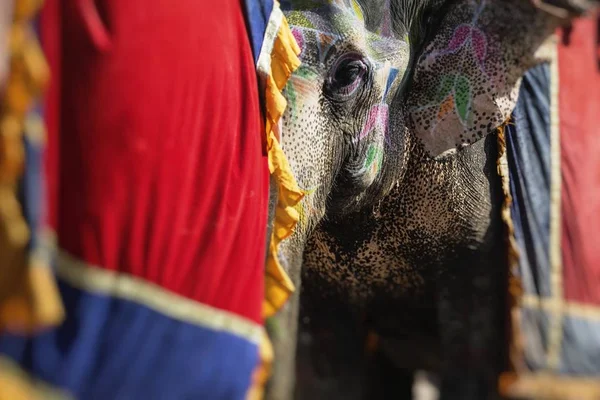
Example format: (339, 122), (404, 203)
(501, 16), (600, 400)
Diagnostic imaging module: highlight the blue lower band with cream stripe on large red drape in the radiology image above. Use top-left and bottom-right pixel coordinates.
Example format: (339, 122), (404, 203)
(0, 254), (262, 399)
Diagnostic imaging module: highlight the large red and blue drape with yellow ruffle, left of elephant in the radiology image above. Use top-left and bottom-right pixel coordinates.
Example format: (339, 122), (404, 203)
(0, 0), (299, 400)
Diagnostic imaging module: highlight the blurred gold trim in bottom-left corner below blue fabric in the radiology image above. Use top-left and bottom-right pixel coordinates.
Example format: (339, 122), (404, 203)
(0, 356), (74, 400)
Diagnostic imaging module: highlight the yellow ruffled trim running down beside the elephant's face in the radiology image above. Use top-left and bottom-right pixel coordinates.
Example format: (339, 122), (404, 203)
(263, 11), (304, 318)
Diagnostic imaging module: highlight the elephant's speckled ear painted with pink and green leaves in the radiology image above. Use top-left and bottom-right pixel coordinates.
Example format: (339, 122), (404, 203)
(407, 0), (598, 158)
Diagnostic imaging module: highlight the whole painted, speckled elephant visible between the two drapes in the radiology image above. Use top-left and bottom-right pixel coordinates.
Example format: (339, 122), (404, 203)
(267, 0), (597, 399)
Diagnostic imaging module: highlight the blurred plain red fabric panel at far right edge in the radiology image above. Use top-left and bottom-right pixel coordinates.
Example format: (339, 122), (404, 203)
(559, 14), (600, 304)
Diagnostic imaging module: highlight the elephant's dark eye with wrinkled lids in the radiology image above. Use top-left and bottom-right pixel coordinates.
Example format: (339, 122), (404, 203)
(328, 54), (369, 95)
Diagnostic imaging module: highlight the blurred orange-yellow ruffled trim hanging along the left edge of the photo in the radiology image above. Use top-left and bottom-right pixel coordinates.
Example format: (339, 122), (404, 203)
(0, 0), (64, 333)
